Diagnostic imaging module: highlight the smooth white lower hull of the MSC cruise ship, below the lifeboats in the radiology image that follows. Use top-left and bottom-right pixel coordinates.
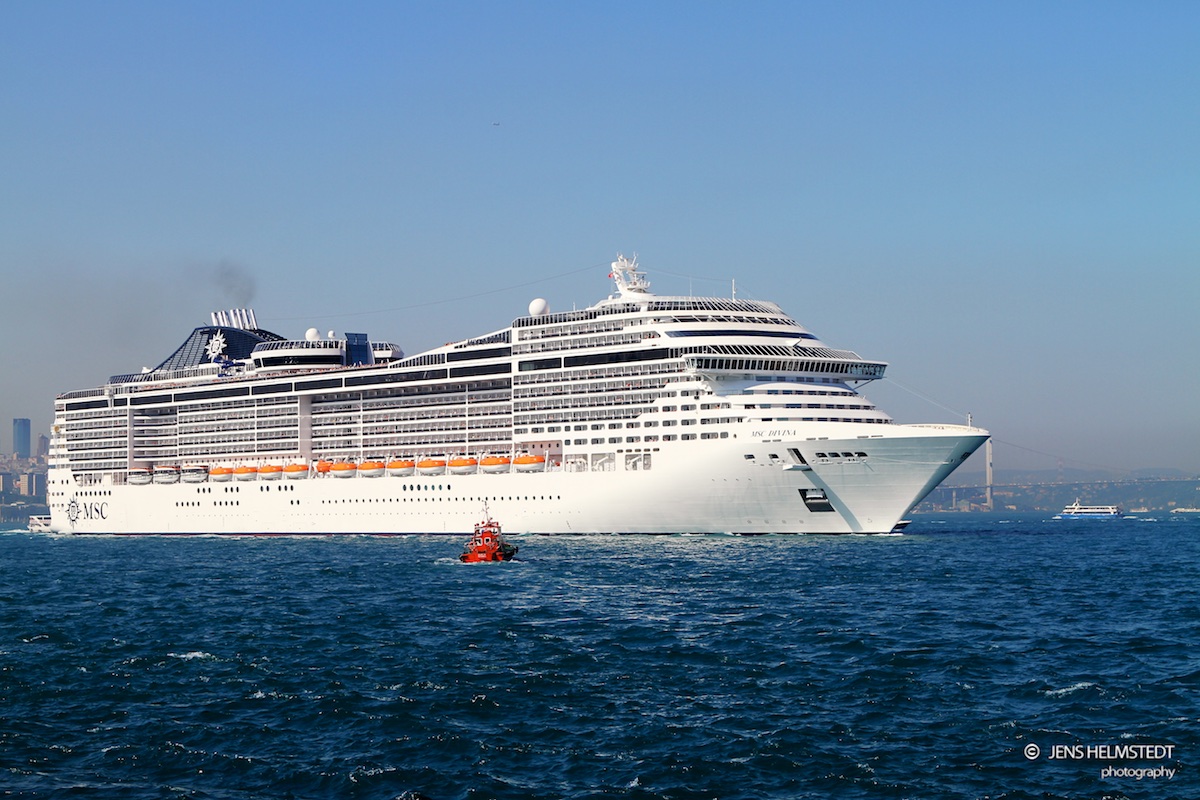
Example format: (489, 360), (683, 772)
(52, 426), (986, 535)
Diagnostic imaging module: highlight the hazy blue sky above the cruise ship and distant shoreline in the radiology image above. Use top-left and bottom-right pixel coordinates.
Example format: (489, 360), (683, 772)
(0, 0), (1200, 473)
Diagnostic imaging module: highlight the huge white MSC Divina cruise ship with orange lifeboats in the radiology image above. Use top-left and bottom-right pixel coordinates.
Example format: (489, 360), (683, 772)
(48, 257), (988, 535)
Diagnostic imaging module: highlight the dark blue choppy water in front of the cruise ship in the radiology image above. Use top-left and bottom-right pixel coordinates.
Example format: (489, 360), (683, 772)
(0, 515), (1200, 800)
